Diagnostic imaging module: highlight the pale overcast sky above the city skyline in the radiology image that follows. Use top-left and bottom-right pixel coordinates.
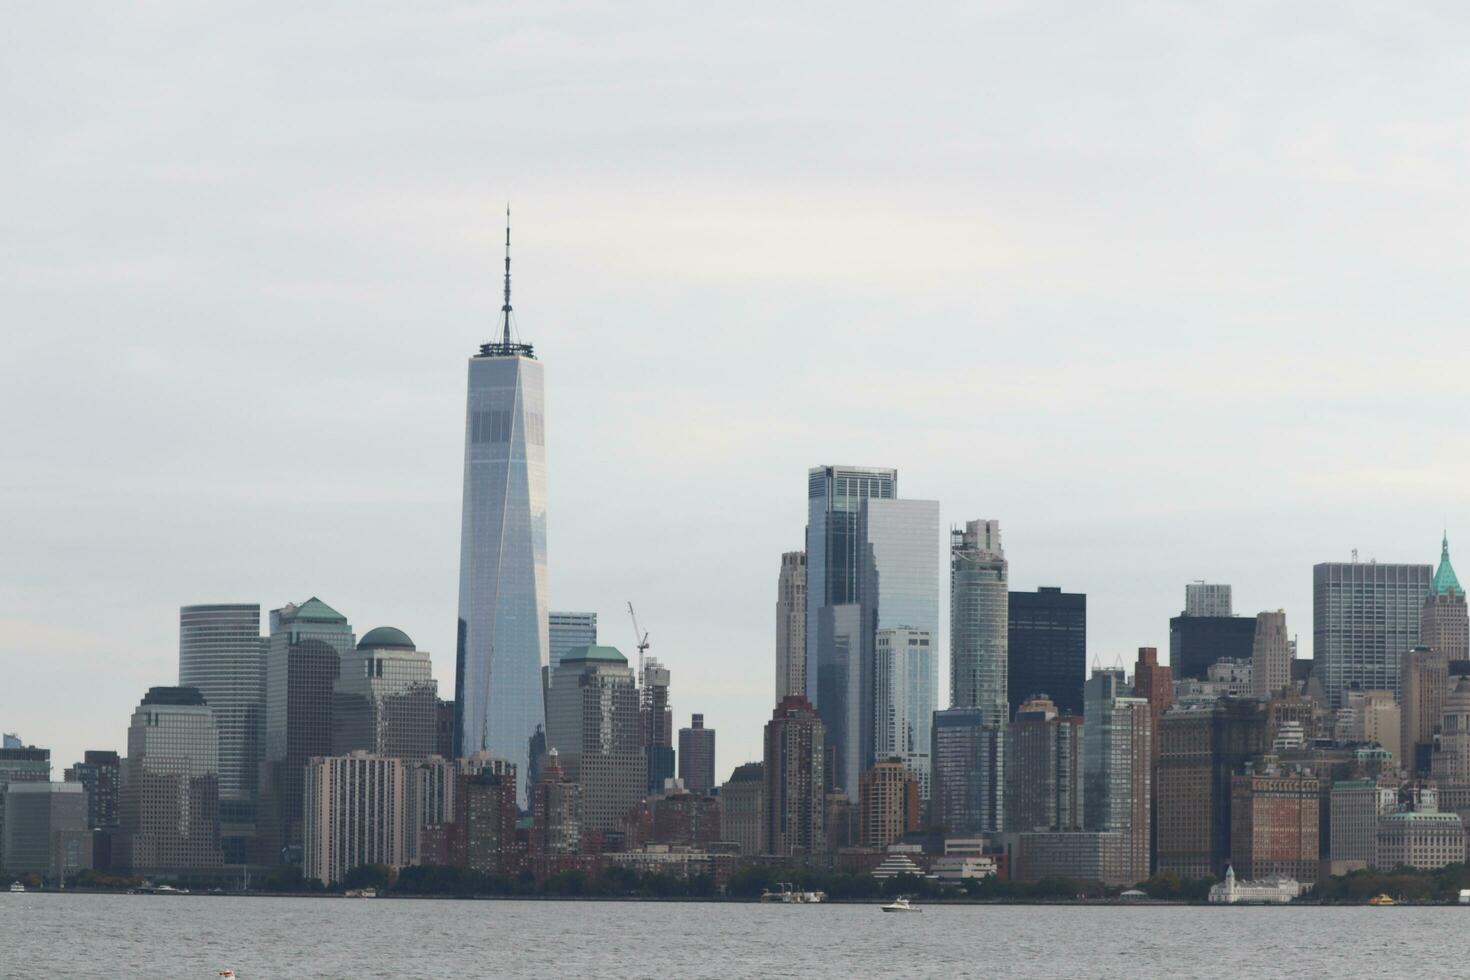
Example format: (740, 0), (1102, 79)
(0, 0), (1470, 779)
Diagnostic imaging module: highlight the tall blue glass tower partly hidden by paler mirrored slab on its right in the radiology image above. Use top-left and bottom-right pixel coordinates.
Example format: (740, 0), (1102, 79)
(806, 466), (893, 793)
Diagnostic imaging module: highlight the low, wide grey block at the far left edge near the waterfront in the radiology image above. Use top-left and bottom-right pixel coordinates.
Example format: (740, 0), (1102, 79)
(0, 780), (93, 884)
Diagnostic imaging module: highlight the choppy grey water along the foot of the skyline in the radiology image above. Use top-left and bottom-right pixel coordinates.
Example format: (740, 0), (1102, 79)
(0, 893), (1470, 980)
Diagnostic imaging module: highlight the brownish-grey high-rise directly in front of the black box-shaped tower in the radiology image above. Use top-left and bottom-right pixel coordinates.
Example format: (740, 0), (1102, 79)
(1005, 698), (1082, 833)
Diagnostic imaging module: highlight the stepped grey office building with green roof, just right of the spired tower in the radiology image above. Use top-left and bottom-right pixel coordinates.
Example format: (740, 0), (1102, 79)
(547, 646), (648, 832)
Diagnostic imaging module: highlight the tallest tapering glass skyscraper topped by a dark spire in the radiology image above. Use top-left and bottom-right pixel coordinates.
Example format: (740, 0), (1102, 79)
(454, 209), (550, 804)
